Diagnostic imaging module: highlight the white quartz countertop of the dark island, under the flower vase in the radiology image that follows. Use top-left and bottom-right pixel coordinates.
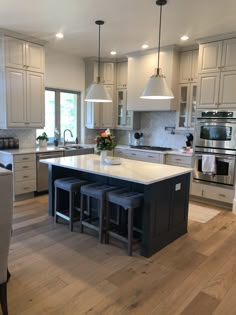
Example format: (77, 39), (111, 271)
(41, 154), (192, 185)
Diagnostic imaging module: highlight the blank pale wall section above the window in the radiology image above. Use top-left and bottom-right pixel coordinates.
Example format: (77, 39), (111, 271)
(45, 47), (85, 92)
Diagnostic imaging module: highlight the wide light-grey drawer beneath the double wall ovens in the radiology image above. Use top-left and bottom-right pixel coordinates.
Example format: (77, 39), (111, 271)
(190, 182), (234, 203)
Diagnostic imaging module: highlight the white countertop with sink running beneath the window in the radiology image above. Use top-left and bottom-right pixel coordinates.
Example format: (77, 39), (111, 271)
(0, 144), (94, 155)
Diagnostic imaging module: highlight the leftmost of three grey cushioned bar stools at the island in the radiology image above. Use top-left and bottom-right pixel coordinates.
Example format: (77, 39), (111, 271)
(54, 177), (88, 232)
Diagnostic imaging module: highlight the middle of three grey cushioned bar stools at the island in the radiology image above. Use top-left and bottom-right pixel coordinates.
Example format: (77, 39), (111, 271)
(80, 183), (117, 243)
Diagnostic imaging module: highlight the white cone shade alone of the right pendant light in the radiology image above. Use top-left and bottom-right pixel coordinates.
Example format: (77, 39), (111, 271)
(140, 75), (174, 100)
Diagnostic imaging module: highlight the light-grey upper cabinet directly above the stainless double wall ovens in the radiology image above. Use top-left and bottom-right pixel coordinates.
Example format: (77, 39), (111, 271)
(198, 38), (236, 108)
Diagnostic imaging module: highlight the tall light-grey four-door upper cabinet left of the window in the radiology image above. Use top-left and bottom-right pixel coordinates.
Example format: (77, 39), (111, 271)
(0, 36), (45, 129)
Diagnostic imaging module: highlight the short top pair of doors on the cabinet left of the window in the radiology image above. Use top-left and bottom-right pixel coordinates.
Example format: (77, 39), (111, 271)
(5, 36), (45, 73)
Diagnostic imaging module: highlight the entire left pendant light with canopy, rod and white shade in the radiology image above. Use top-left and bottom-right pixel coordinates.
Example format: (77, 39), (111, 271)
(85, 20), (112, 103)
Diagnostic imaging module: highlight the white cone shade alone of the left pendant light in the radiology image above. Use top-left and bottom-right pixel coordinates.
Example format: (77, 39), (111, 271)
(85, 82), (112, 103)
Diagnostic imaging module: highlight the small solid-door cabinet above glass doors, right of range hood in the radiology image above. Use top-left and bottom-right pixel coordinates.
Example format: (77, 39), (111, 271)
(179, 50), (198, 83)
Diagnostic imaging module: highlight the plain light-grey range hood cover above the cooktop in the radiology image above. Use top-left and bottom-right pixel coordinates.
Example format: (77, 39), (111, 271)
(127, 48), (179, 111)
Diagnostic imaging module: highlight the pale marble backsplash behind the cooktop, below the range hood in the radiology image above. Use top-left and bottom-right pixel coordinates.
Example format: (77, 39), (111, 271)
(85, 111), (193, 149)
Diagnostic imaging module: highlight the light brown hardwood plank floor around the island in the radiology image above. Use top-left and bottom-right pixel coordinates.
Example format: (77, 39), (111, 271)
(8, 196), (236, 315)
